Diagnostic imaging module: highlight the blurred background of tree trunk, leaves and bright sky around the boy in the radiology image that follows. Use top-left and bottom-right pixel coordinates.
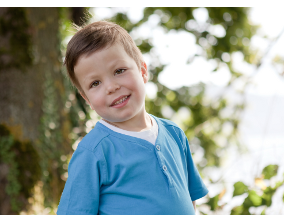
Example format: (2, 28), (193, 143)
(0, 7), (284, 215)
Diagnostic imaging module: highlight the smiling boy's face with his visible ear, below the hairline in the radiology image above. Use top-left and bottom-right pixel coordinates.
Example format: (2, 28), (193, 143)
(74, 44), (148, 123)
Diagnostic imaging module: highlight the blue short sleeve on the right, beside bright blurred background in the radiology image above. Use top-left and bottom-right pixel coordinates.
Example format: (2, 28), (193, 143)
(184, 135), (208, 201)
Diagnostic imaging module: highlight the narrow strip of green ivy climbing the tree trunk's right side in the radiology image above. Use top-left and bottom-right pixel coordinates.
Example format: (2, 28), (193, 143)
(39, 70), (66, 207)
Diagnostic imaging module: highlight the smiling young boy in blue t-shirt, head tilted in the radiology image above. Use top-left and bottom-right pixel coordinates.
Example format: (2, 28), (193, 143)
(57, 21), (208, 215)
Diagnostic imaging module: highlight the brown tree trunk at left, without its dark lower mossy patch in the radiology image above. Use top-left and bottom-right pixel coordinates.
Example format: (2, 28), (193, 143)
(0, 8), (70, 214)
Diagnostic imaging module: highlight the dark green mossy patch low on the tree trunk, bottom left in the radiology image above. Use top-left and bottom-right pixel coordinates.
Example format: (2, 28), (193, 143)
(0, 124), (41, 214)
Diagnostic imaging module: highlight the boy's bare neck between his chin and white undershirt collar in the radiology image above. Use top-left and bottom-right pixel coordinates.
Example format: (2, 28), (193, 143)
(103, 111), (153, 132)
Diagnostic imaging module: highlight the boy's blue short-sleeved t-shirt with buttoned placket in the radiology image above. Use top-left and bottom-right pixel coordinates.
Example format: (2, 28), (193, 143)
(57, 116), (208, 215)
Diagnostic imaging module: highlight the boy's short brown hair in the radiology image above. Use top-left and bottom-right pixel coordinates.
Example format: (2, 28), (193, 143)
(64, 21), (144, 94)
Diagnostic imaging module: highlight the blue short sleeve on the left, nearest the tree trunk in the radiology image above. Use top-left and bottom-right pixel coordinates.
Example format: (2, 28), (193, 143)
(57, 146), (100, 215)
